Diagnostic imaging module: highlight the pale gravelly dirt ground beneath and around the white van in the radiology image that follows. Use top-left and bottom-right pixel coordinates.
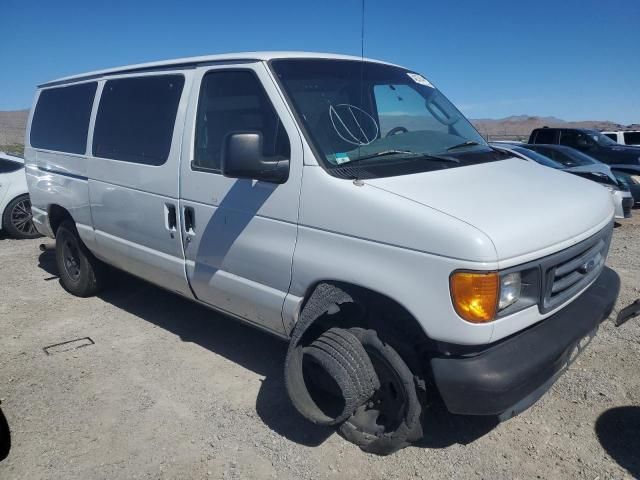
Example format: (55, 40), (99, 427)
(0, 216), (640, 480)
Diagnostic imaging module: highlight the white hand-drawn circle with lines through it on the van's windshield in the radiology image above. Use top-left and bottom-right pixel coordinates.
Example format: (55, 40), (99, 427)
(329, 103), (380, 146)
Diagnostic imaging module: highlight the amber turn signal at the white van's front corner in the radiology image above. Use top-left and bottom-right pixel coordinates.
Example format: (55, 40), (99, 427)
(449, 272), (500, 323)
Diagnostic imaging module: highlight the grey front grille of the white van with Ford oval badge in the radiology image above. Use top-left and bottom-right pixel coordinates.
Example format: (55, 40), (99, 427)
(540, 225), (613, 313)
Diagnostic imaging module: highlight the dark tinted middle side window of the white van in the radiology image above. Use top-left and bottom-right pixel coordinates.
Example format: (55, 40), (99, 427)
(93, 75), (184, 165)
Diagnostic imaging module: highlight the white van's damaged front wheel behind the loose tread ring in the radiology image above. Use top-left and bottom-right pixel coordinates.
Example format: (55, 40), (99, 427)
(340, 328), (423, 455)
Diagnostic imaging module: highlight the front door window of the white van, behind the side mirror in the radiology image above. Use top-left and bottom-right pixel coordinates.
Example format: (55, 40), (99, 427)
(192, 70), (290, 172)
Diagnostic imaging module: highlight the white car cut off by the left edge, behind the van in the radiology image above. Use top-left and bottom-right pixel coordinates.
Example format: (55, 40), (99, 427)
(0, 152), (40, 238)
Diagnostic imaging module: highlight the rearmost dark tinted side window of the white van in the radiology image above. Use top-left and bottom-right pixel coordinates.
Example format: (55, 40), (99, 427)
(29, 82), (98, 154)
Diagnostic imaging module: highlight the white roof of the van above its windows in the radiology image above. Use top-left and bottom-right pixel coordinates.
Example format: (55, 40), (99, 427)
(38, 51), (400, 88)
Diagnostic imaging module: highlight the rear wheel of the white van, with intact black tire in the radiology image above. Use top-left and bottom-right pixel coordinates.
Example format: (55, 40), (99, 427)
(56, 220), (105, 297)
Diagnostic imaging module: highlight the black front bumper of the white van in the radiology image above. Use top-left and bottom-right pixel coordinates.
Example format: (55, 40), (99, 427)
(431, 267), (620, 419)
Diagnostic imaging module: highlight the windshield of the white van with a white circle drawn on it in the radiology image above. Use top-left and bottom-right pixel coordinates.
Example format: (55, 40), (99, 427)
(271, 59), (504, 174)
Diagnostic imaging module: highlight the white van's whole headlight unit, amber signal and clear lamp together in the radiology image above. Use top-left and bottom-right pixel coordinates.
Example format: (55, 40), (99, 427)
(449, 266), (540, 323)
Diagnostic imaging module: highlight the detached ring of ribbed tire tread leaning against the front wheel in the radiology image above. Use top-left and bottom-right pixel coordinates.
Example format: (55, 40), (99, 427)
(285, 328), (378, 425)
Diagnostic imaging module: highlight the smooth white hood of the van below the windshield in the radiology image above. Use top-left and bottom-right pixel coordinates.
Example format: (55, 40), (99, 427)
(365, 158), (613, 262)
